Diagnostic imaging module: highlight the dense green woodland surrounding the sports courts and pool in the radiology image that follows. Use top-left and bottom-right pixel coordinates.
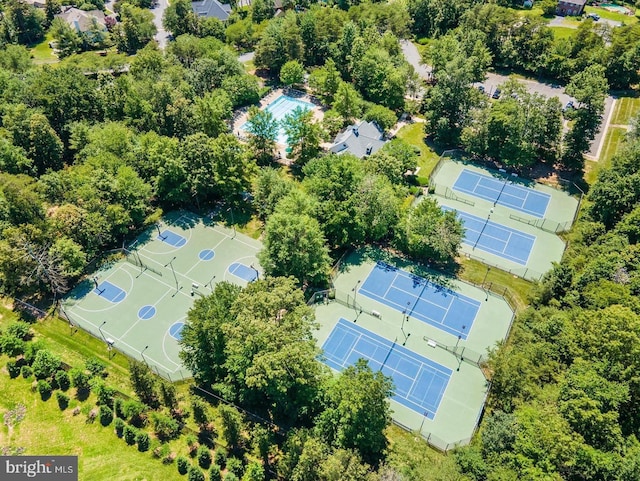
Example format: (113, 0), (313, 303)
(0, 0), (640, 481)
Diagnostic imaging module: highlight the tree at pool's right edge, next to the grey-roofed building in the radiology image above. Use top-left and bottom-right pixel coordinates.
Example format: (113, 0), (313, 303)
(282, 107), (322, 165)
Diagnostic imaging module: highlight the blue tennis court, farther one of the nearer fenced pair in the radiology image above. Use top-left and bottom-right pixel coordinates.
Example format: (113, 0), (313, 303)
(358, 262), (480, 339)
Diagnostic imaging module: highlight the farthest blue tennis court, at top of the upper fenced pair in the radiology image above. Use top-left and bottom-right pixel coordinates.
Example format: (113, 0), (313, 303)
(453, 169), (551, 219)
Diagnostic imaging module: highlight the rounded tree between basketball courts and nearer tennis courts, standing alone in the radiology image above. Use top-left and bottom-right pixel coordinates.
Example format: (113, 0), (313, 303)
(258, 210), (331, 286)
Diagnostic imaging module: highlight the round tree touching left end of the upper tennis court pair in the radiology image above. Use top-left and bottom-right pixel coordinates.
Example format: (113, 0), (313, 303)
(397, 198), (464, 264)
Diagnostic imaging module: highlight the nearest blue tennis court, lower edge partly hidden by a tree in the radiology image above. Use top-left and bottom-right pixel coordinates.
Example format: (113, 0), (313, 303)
(322, 319), (452, 419)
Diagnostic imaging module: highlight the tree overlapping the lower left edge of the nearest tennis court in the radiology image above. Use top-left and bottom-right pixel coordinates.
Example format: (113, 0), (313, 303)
(316, 359), (392, 463)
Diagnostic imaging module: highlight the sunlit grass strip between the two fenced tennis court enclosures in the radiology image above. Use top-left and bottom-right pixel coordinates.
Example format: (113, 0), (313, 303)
(458, 256), (533, 312)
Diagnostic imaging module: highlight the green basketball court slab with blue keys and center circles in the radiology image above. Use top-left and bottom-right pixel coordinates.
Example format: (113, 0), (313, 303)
(61, 211), (261, 380)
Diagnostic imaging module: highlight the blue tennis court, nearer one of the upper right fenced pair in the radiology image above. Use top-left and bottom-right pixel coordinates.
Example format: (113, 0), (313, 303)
(457, 211), (536, 266)
